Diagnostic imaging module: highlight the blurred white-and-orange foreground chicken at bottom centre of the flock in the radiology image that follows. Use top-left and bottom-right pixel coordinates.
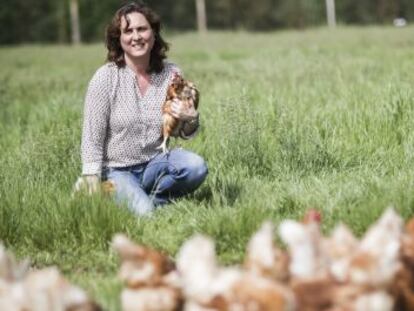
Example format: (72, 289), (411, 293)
(177, 235), (295, 311)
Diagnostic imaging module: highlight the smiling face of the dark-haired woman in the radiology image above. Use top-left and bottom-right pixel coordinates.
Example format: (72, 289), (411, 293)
(120, 12), (155, 59)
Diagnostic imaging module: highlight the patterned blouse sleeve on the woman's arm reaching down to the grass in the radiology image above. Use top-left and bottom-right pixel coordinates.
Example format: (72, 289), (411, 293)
(81, 66), (110, 175)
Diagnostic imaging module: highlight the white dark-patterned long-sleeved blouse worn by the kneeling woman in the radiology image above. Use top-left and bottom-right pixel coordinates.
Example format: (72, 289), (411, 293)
(81, 62), (198, 175)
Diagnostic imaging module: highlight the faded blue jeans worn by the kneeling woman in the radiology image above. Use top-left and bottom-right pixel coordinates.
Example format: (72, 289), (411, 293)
(104, 149), (208, 215)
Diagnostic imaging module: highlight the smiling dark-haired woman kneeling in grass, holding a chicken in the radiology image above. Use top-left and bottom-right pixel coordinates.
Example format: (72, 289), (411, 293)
(81, 2), (207, 215)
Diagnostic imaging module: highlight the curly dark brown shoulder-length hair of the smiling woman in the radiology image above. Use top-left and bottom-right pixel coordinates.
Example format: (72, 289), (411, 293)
(105, 1), (169, 73)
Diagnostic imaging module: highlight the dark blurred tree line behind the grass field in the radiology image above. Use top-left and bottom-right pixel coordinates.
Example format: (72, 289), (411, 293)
(0, 0), (414, 44)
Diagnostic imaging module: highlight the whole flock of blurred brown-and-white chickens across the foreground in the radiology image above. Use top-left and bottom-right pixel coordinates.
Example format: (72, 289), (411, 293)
(0, 209), (414, 311)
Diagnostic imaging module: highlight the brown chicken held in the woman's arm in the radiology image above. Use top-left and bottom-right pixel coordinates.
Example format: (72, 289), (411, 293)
(158, 74), (200, 153)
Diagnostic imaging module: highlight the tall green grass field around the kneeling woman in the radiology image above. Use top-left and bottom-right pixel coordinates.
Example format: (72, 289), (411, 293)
(0, 27), (414, 310)
